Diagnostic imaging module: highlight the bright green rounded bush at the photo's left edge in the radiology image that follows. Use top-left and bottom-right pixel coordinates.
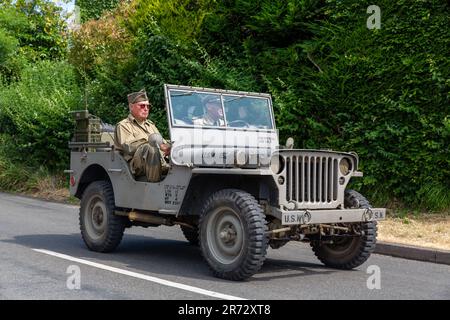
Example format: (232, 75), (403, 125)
(0, 61), (81, 170)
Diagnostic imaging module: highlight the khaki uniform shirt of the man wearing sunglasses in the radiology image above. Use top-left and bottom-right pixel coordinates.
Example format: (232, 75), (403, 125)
(114, 114), (167, 161)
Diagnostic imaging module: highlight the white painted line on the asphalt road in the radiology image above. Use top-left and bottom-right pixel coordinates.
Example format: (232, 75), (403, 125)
(33, 249), (247, 300)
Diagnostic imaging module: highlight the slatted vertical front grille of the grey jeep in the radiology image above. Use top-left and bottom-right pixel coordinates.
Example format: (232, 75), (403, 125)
(285, 156), (339, 203)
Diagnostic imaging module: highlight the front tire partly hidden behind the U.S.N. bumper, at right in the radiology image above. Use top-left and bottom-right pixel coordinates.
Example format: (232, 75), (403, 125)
(311, 190), (377, 270)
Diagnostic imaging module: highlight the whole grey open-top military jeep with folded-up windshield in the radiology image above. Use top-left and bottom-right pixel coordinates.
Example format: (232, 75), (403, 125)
(67, 85), (386, 280)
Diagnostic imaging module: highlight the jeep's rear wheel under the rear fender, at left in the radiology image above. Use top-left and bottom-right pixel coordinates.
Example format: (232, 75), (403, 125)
(79, 181), (127, 252)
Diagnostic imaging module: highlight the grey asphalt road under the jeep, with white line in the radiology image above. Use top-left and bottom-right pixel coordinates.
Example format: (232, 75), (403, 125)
(0, 193), (450, 300)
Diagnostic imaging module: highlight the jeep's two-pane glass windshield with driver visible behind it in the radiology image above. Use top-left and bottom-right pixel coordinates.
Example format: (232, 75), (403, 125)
(168, 89), (274, 130)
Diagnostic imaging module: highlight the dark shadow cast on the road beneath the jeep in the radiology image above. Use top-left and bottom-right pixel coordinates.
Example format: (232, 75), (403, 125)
(1, 234), (337, 282)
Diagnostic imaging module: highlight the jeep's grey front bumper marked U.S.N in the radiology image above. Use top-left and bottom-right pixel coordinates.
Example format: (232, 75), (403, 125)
(277, 208), (386, 225)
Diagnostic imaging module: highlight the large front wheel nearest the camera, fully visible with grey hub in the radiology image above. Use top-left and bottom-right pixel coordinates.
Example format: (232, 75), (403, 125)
(199, 189), (268, 280)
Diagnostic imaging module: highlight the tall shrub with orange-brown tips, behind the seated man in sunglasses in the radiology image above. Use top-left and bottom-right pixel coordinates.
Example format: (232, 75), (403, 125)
(69, 4), (135, 123)
